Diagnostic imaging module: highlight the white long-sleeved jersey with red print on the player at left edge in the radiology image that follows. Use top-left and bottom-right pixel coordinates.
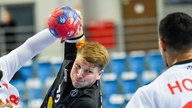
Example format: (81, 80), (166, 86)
(0, 29), (56, 106)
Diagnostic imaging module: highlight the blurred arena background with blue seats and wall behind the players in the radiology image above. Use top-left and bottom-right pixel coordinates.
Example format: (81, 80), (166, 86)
(0, 0), (192, 108)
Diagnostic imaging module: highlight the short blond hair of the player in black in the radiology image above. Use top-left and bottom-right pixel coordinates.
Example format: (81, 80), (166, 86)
(77, 42), (109, 70)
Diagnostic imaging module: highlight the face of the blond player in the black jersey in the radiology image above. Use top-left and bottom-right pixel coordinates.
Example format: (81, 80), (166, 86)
(70, 55), (103, 88)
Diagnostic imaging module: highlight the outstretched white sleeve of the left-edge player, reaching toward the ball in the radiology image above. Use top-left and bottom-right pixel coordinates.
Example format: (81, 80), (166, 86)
(0, 29), (56, 81)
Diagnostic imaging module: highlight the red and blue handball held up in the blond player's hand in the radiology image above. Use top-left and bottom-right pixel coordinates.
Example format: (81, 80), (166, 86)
(48, 6), (80, 40)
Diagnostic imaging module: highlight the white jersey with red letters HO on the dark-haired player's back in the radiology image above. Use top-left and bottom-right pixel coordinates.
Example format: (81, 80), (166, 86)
(126, 60), (192, 108)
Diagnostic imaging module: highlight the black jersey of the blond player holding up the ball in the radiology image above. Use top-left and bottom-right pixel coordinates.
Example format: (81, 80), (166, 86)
(41, 37), (101, 108)
